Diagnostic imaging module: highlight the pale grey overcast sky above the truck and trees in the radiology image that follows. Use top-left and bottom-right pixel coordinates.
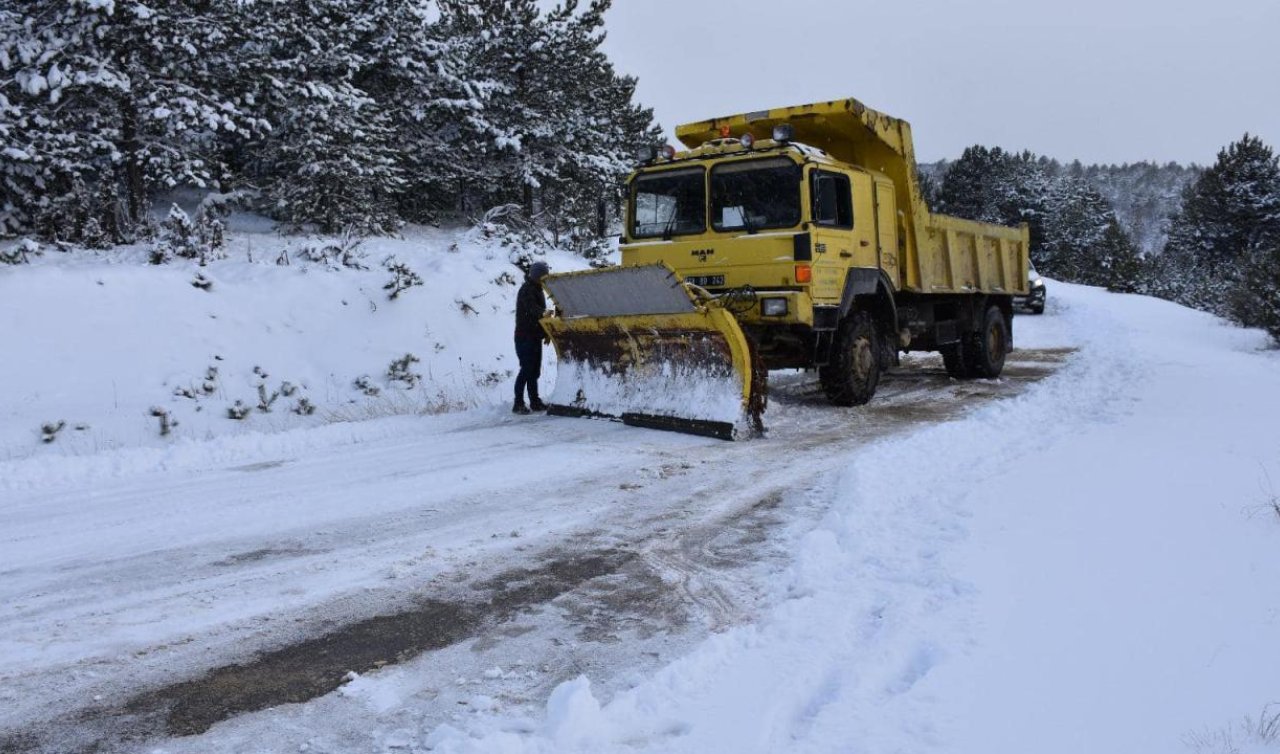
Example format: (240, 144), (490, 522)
(605, 0), (1280, 164)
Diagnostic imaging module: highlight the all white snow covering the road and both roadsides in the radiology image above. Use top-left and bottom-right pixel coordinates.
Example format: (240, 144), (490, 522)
(0, 239), (1280, 754)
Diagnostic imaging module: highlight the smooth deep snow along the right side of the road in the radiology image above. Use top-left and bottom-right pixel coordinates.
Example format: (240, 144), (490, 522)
(421, 285), (1280, 753)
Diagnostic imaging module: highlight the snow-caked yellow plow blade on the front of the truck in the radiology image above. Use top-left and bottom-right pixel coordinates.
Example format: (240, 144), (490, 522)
(543, 265), (764, 439)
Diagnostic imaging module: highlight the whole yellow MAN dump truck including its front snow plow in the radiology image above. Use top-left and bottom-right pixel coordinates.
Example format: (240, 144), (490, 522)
(543, 99), (1029, 438)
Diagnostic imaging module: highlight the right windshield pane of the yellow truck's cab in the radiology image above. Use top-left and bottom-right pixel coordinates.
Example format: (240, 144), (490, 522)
(712, 157), (800, 233)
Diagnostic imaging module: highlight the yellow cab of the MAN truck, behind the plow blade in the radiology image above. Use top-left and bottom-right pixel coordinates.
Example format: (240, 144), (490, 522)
(622, 137), (899, 369)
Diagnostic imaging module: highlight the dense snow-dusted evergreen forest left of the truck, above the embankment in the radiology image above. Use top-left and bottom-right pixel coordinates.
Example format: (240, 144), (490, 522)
(0, 0), (658, 253)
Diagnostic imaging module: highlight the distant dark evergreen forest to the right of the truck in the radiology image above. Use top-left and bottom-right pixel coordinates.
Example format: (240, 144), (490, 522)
(922, 134), (1280, 341)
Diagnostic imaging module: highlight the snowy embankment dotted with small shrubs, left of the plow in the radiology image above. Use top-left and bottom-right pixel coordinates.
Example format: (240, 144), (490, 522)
(0, 218), (584, 488)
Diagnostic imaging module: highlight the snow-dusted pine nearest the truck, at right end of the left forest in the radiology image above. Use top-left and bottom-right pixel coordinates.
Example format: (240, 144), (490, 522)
(432, 0), (658, 241)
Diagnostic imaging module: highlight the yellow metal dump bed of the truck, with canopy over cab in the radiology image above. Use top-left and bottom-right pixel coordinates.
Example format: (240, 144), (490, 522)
(676, 99), (1029, 294)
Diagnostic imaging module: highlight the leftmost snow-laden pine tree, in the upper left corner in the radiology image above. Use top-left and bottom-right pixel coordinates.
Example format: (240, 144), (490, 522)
(0, 0), (261, 241)
